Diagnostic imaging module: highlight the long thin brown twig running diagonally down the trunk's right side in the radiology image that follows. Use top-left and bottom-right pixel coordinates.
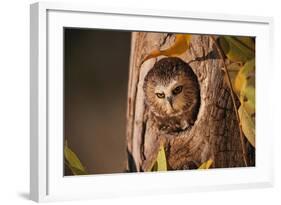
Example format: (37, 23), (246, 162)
(211, 36), (248, 167)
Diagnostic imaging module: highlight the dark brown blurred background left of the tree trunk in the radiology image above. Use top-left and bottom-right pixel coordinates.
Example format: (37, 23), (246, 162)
(64, 28), (131, 175)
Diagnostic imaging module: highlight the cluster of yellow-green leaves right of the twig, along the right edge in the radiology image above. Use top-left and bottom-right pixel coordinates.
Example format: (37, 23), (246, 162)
(218, 36), (256, 147)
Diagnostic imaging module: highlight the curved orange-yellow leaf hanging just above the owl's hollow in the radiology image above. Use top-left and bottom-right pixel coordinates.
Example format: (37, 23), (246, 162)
(144, 34), (192, 61)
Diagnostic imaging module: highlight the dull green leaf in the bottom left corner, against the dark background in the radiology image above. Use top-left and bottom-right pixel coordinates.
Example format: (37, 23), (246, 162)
(64, 143), (88, 175)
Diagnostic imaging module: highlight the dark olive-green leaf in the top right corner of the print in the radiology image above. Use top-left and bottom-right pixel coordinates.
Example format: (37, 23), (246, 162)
(219, 36), (255, 63)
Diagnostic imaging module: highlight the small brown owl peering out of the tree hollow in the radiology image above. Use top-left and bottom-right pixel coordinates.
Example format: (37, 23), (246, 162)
(143, 57), (200, 133)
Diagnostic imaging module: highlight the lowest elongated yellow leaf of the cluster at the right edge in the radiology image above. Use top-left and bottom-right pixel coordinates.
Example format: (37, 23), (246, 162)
(238, 104), (256, 147)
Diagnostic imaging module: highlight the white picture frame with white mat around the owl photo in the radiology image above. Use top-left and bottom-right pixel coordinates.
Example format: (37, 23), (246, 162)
(30, 2), (273, 202)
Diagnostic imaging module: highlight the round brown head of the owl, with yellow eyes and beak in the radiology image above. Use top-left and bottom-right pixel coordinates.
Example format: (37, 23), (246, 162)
(143, 57), (200, 117)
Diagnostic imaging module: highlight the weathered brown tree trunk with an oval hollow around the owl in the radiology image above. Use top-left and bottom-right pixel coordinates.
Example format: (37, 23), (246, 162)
(127, 32), (255, 171)
